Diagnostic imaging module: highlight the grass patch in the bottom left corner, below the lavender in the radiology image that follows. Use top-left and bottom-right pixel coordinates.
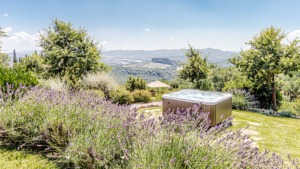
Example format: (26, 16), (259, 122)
(0, 146), (58, 169)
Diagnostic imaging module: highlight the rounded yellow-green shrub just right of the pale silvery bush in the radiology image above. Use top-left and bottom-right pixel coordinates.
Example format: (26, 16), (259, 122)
(109, 86), (134, 105)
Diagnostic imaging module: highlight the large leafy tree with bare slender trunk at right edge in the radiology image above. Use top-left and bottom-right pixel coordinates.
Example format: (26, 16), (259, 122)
(229, 26), (300, 110)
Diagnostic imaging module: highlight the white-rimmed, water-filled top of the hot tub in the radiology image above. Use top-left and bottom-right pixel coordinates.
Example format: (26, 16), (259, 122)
(162, 89), (232, 105)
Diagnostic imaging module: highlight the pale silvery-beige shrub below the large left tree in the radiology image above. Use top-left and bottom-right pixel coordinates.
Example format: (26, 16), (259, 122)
(82, 72), (118, 96)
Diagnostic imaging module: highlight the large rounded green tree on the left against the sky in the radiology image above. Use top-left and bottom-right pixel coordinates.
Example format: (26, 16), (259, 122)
(39, 18), (108, 87)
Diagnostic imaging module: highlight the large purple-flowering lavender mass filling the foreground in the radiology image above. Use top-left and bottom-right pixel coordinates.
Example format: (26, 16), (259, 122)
(0, 87), (299, 168)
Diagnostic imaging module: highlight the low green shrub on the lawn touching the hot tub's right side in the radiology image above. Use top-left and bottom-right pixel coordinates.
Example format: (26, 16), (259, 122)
(226, 89), (258, 110)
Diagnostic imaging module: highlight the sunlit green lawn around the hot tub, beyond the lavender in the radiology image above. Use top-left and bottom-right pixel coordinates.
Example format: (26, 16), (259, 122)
(139, 107), (300, 162)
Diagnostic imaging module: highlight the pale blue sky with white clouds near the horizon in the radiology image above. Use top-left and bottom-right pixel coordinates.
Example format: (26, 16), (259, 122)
(0, 0), (300, 52)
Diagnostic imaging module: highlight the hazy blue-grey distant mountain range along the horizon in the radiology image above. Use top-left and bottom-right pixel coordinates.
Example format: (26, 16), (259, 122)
(5, 48), (238, 67)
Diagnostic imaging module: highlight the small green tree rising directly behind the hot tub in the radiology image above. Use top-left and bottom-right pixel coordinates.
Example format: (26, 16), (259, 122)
(178, 44), (217, 88)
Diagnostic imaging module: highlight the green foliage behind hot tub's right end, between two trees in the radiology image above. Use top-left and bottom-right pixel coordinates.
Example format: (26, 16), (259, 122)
(208, 66), (242, 92)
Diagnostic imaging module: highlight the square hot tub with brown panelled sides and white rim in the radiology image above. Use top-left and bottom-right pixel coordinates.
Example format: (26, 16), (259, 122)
(162, 89), (232, 126)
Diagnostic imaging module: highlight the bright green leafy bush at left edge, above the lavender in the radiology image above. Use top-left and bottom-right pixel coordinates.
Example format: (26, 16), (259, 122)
(0, 65), (39, 91)
